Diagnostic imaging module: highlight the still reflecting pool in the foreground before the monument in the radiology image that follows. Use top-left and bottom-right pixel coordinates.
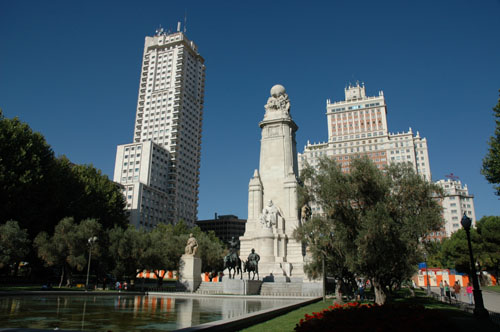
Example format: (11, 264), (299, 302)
(0, 295), (300, 332)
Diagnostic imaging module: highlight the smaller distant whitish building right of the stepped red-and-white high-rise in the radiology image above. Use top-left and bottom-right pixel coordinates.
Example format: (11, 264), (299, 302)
(436, 178), (476, 237)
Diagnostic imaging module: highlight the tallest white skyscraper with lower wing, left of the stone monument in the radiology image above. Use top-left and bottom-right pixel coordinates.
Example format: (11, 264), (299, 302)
(114, 24), (205, 227)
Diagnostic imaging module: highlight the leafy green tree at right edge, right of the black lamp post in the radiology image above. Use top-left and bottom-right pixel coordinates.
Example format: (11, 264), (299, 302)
(477, 216), (500, 280)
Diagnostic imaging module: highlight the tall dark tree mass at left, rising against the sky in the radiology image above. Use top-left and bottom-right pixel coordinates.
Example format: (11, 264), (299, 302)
(0, 110), (127, 239)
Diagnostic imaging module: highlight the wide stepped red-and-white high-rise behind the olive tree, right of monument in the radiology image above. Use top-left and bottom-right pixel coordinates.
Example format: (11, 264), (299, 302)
(298, 83), (431, 213)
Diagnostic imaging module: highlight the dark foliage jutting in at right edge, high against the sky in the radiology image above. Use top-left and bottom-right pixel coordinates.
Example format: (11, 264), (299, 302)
(481, 89), (500, 196)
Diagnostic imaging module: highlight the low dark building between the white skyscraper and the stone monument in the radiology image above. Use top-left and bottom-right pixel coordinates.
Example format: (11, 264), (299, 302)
(196, 213), (247, 244)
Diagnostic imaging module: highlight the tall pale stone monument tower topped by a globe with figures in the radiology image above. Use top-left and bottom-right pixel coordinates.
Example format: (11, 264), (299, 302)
(240, 85), (305, 281)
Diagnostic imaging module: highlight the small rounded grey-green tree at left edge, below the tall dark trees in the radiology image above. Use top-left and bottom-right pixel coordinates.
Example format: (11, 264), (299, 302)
(0, 220), (30, 275)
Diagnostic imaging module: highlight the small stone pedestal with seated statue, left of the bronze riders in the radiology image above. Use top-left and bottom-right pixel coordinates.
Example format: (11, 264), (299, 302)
(179, 234), (201, 292)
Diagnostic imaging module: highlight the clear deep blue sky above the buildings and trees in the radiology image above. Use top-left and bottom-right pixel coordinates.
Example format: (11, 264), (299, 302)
(0, 0), (500, 219)
